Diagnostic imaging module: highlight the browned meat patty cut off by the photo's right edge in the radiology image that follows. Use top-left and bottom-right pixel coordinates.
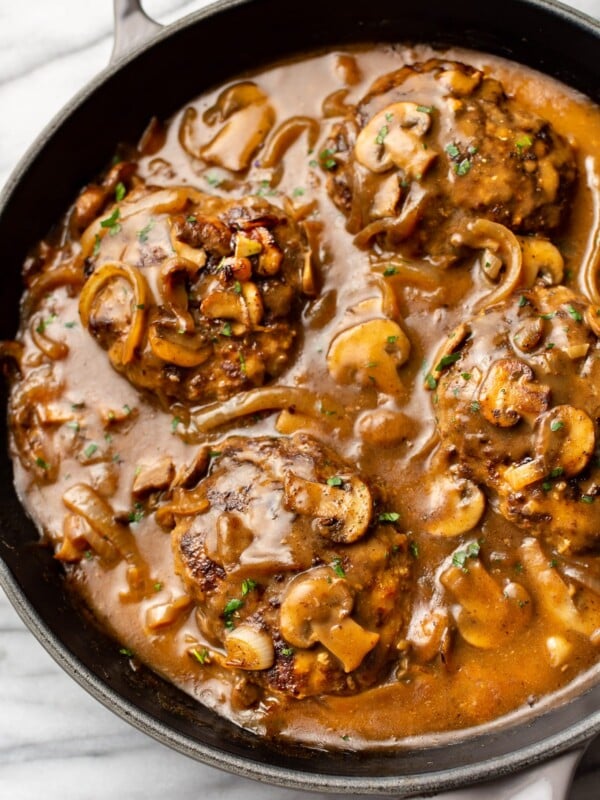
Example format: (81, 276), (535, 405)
(429, 286), (600, 552)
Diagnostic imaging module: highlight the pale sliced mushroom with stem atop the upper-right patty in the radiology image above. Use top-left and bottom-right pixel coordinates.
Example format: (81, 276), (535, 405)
(355, 102), (437, 179)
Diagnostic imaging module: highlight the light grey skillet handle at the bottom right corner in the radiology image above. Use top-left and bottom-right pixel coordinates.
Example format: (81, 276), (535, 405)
(432, 748), (585, 800)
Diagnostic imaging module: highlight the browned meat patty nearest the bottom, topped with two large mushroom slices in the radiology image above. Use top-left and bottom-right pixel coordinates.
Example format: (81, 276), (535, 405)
(169, 434), (409, 697)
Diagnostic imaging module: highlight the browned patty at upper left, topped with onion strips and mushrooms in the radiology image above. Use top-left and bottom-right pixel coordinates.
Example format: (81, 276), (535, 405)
(80, 187), (314, 404)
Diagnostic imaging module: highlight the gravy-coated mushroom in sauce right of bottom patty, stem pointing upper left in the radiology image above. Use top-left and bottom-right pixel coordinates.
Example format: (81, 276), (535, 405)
(440, 551), (532, 650)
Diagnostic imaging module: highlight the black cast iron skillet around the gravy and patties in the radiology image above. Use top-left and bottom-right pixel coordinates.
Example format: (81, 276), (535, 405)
(0, 0), (600, 798)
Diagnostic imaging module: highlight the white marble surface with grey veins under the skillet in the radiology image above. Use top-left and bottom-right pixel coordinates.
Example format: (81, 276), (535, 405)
(0, 0), (600, 800)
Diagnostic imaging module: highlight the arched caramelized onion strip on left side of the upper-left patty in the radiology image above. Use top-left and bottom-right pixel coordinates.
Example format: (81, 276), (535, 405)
(79, 262), (150, 364)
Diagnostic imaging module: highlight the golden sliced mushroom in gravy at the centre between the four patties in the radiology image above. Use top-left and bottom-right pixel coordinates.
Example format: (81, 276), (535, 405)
(327, 319), (410, 394)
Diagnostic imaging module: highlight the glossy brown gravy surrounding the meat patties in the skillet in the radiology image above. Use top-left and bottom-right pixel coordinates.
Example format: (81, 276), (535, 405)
(7, 46), (600, 749)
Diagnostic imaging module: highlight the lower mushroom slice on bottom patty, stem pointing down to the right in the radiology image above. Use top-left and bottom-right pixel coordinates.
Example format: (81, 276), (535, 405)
(279, 567), (379, 672)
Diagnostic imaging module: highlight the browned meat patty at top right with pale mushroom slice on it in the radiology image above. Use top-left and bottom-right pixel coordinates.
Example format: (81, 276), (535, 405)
(320, 59), (576, 265)
